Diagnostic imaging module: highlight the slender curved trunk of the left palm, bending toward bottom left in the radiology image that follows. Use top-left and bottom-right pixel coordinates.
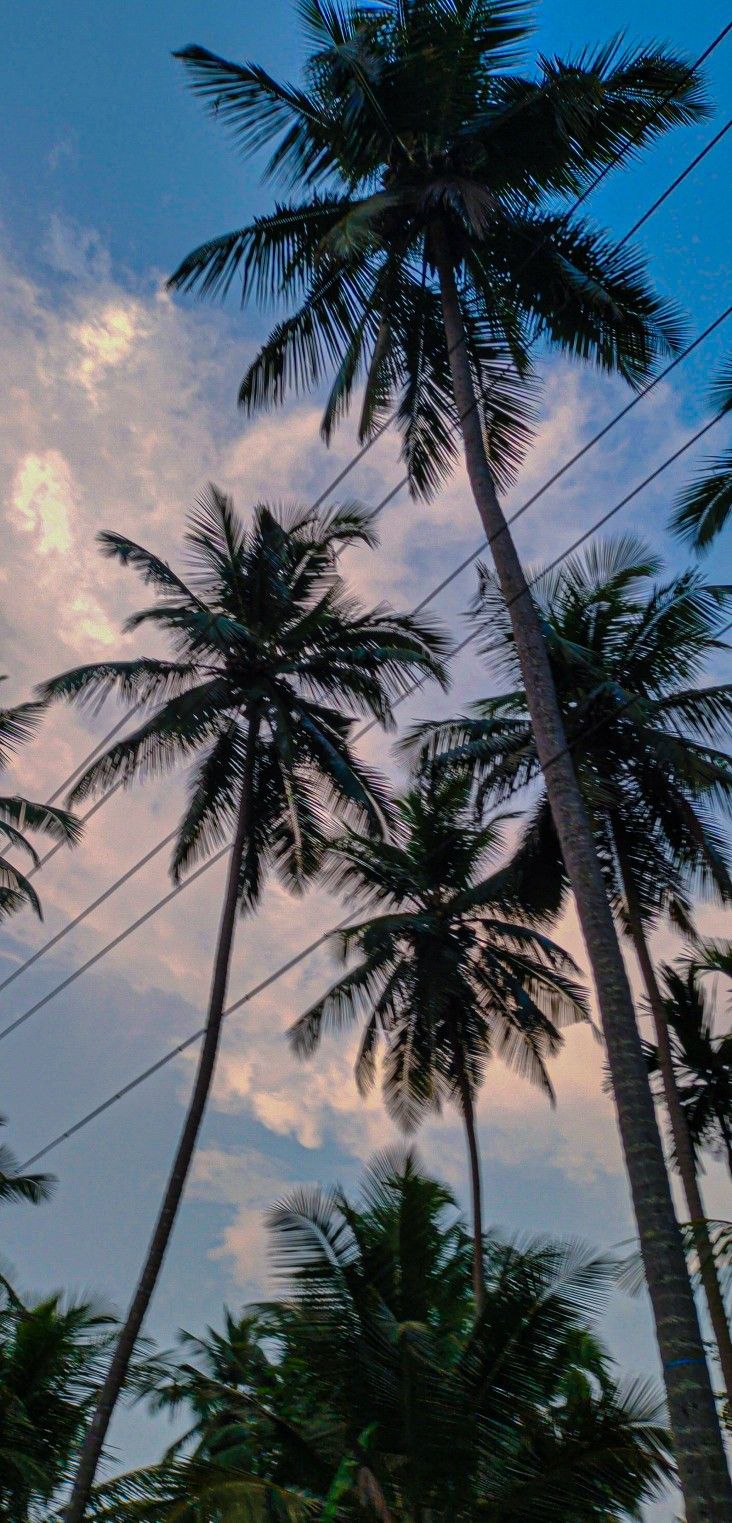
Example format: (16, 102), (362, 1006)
(65, 714), (259, 1523)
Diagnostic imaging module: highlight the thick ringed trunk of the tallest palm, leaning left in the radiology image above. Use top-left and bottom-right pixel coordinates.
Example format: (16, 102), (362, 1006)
(432, 234), (732, 1523)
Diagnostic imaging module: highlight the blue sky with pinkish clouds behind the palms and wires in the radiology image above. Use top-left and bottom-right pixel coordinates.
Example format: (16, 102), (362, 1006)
(0, 0), (732, 1517)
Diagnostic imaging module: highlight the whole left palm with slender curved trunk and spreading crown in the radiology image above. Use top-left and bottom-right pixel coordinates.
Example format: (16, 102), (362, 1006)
(43, 486), (444, 1523)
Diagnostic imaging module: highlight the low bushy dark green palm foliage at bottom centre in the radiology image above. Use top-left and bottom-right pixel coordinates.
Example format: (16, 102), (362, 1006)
(94, 1154), (670, 1523)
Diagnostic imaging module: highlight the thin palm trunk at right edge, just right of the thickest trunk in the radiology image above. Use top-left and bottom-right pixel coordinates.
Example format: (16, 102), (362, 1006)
(615, 835), (732, 1407)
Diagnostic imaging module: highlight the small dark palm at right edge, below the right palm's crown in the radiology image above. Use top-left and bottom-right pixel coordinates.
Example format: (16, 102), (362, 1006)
(648, 944), (732, 1176)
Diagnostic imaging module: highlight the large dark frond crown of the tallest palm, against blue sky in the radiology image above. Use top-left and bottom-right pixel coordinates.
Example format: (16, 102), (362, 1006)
(170, 0), (705, 492)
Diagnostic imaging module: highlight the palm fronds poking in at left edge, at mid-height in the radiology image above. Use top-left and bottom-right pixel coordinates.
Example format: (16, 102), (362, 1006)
(0, 678), (82, 920)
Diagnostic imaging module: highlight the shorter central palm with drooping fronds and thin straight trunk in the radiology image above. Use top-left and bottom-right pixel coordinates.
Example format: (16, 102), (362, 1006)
(291, 777), (587, 1308)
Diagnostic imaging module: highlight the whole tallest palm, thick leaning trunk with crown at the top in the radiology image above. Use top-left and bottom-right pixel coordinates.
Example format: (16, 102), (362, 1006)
(166, 0), (732, 1523)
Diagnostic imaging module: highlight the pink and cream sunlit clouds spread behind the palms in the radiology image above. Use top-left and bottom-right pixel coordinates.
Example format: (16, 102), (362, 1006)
(0, 222), (718, 1321)
